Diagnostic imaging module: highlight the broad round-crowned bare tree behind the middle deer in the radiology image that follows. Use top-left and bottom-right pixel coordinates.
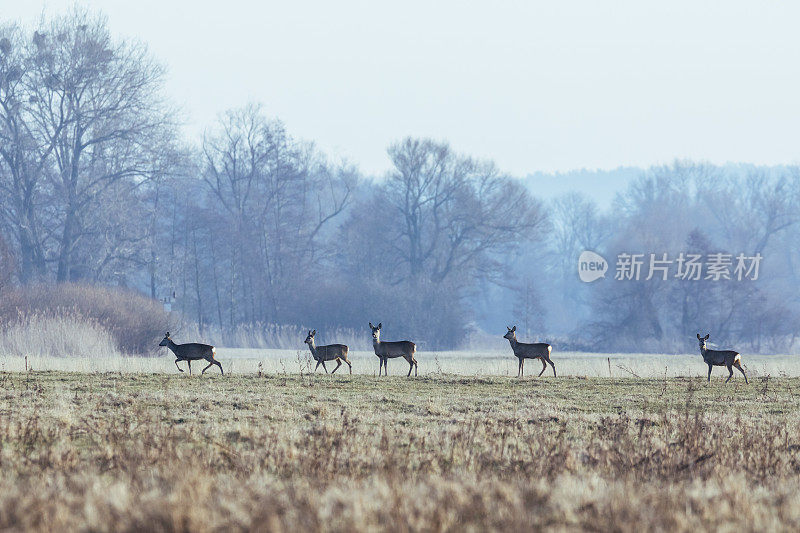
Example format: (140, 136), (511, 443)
(339, 138), (546, 347)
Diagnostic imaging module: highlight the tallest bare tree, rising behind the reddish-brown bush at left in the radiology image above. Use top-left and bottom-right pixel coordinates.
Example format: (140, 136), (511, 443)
(24, 10), (173, 281)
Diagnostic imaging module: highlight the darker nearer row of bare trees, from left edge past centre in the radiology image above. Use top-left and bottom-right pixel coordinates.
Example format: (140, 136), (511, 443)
(0, 11), (545, 348)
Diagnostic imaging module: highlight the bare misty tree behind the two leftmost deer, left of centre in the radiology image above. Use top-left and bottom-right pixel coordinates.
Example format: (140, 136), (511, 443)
(197, 105), (358, 322)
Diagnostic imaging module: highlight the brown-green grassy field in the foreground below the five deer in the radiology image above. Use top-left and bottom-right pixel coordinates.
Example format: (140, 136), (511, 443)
(0, 363), (800, 531)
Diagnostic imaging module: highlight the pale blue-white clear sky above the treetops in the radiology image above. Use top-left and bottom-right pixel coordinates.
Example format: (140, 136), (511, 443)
(0, 0), (800, 176)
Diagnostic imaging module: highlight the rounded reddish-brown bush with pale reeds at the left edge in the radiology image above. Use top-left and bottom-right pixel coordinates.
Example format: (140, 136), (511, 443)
(0, 284), (175, 355)
